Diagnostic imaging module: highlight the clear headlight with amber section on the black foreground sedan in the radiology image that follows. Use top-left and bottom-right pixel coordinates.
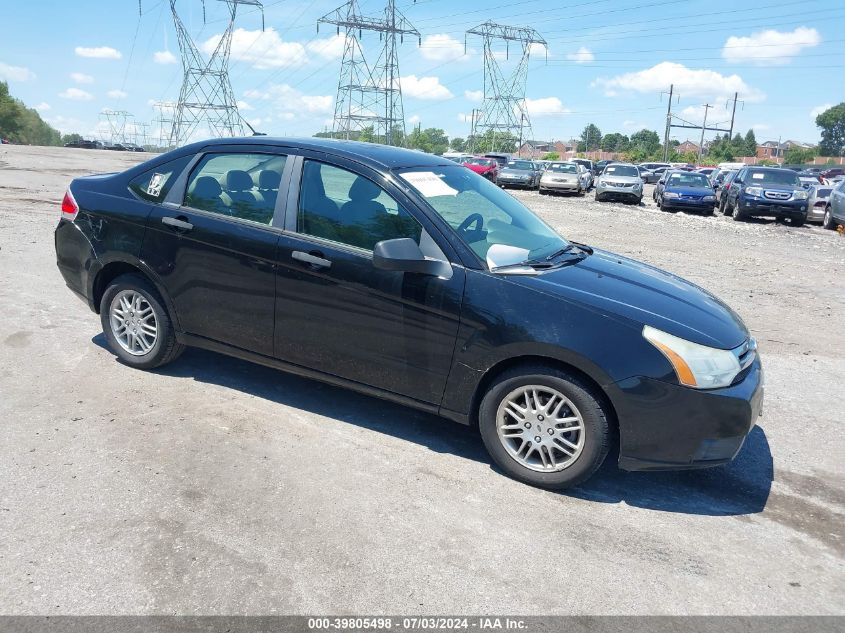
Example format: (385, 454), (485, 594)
(643, 325), (742, 389)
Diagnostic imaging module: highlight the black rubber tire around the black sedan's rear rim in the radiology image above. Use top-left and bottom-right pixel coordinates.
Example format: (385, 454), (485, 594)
(100, 273), (185, 369)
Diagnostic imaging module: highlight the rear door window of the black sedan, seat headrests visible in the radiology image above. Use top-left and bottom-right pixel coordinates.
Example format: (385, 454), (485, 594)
(184, 152), (286, 224)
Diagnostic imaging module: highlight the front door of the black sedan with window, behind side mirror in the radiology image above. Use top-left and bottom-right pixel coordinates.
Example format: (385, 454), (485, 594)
(275, 153), (465, 404)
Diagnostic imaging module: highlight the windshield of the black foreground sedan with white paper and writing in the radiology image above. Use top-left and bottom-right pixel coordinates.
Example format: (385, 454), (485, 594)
(398, 161), (569, 267)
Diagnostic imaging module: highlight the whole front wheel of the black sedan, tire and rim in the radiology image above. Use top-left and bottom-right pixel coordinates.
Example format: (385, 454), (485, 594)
(478, 366), (610, 489)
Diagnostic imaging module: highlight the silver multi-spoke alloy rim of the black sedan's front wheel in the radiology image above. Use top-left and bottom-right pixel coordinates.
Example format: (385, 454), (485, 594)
(496, 385), (584, 473)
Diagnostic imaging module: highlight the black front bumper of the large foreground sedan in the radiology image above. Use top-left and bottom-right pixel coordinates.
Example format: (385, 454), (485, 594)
(612, 357), (763, 470)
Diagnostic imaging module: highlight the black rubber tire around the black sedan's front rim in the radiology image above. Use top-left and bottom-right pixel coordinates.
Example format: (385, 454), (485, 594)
(478, 365), (611, 490)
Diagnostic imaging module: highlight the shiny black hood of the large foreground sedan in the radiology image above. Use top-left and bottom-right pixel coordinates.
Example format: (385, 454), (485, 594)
(511, 249), (748, 349)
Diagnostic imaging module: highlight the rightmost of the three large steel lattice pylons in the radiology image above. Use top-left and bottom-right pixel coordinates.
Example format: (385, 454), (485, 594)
(464, 20), (548, 150)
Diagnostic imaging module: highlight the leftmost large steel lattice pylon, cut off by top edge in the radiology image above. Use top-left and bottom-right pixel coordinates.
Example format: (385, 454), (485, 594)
(163, 0), (264, 147)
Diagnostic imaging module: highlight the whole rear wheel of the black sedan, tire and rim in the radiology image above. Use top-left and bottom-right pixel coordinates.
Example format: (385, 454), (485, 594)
(100, 274), (184, 369)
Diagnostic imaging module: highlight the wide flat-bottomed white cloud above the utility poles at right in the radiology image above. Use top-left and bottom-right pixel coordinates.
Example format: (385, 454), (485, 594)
(592, 62), (766, 101)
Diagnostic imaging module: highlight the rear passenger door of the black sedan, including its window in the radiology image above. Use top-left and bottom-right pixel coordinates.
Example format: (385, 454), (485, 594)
(141, 146), (288, 356)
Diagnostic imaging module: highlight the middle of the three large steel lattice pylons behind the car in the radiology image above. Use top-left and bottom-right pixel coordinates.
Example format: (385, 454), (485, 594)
(317, 0), (422, 145)
